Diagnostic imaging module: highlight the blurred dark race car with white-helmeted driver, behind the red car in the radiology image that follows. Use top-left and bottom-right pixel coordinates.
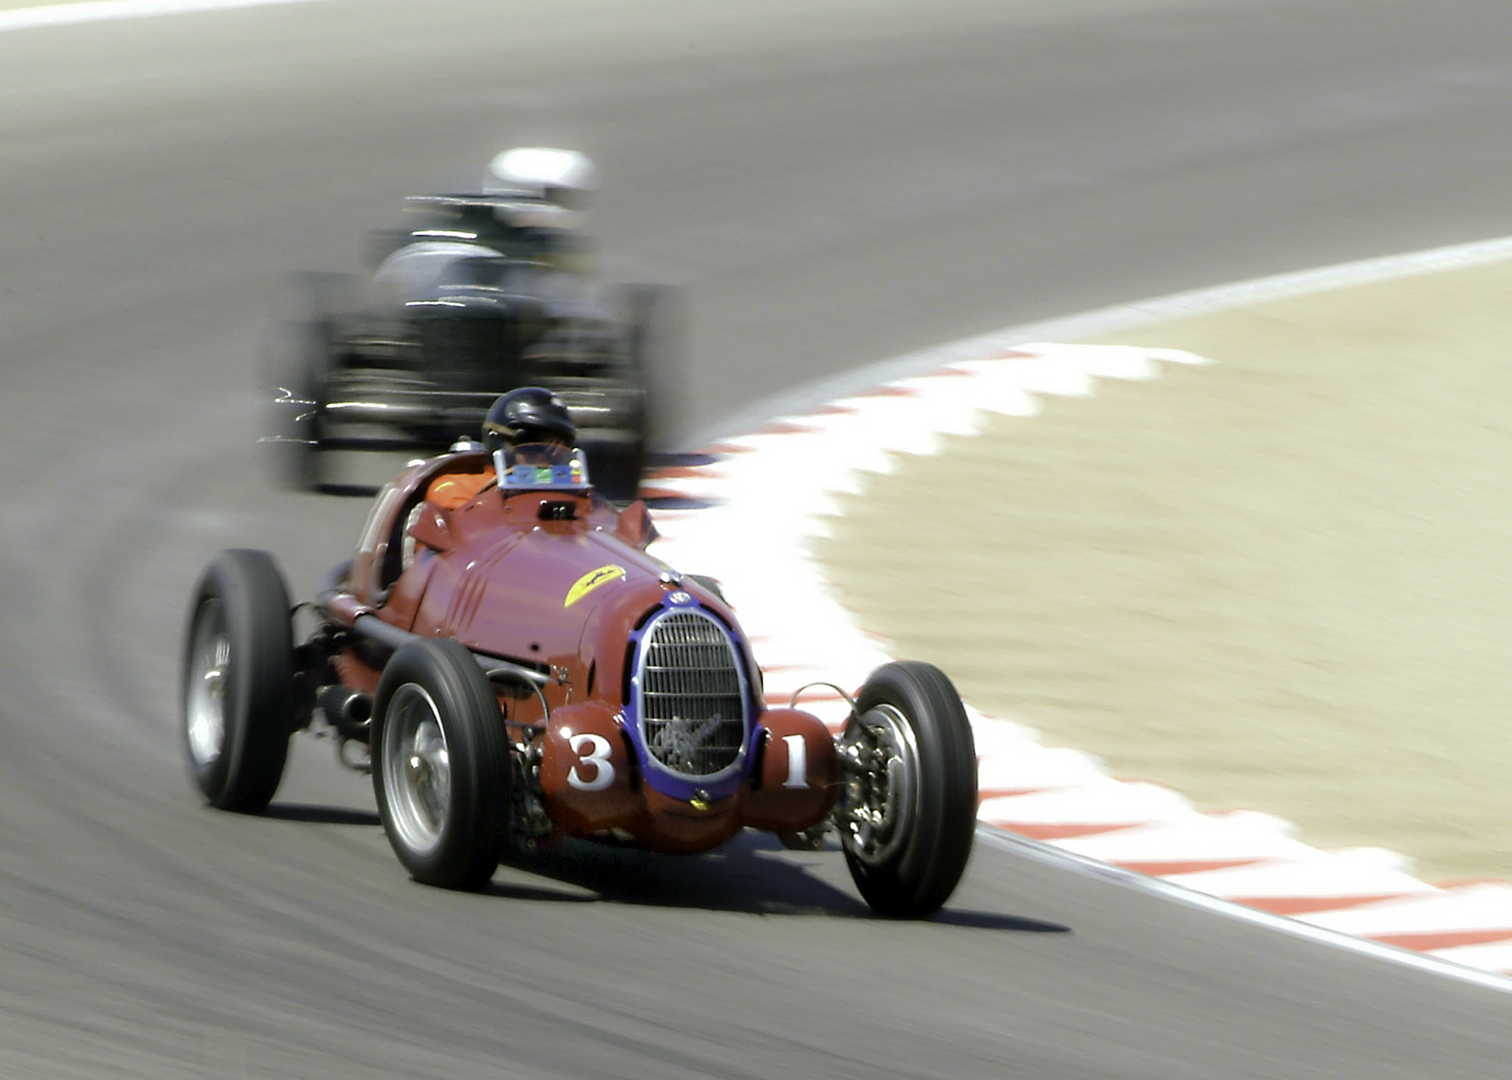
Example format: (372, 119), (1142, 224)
(263, 148), (674, 499)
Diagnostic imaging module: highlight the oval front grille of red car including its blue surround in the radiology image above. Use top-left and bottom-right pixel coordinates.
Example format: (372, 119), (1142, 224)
(626, 593), (758, 802)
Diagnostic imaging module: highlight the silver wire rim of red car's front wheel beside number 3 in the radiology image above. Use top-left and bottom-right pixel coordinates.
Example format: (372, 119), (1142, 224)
(383, 682), (452, 855)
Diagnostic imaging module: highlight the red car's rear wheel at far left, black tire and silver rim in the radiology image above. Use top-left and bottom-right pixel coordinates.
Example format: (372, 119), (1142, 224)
(183, 549), (295, 814)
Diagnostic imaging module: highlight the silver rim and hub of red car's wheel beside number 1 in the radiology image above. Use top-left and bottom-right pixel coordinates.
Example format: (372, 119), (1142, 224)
(836, 705), (919, 865)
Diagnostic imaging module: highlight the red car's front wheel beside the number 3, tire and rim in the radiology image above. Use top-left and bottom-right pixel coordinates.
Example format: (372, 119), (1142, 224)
(372, 638), (510, 889)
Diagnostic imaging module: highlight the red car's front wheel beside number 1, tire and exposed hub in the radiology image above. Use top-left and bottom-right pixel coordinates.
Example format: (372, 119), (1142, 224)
(836, 661), (977, 918)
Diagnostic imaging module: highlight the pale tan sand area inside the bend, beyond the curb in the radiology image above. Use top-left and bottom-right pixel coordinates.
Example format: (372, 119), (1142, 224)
(818, 262), (1512, 883)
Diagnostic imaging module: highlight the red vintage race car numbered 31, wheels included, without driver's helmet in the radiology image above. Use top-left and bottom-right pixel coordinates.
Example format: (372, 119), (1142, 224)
(183, 449), (977, 917)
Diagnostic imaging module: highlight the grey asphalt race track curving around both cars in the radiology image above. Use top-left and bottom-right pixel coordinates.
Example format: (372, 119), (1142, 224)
(0, 0), (1512, 1078)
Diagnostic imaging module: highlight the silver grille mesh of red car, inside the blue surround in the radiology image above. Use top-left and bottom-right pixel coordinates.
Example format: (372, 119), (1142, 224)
(640, 611), (745, 776)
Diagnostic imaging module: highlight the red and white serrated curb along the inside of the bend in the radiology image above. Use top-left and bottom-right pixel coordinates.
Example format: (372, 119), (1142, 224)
(643, 329), (1512, 989)
